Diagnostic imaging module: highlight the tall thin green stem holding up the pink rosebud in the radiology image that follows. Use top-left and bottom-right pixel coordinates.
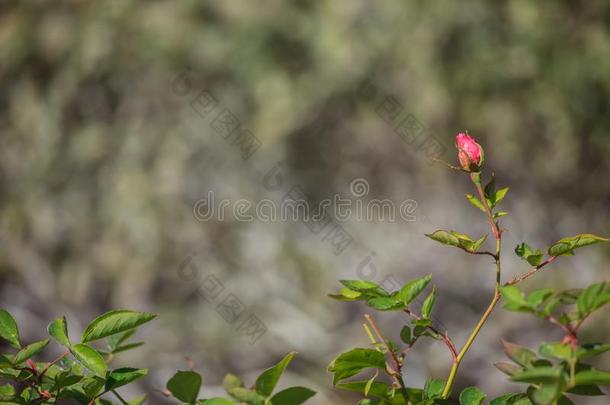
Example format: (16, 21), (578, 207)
(442, 173), (502, 398)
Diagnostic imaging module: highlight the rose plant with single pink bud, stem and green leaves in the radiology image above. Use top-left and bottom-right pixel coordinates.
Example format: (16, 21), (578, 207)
(328, 132), (610, 405)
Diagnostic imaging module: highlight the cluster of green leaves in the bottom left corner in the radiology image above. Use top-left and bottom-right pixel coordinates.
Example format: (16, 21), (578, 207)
(0, 309), (156, 405)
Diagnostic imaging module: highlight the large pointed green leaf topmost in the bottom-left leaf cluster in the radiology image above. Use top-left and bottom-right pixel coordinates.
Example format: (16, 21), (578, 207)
(81, 309), (156, 343)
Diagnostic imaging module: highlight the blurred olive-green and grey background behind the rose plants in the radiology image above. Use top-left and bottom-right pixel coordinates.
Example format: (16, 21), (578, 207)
(0, 0), (610, 404)
